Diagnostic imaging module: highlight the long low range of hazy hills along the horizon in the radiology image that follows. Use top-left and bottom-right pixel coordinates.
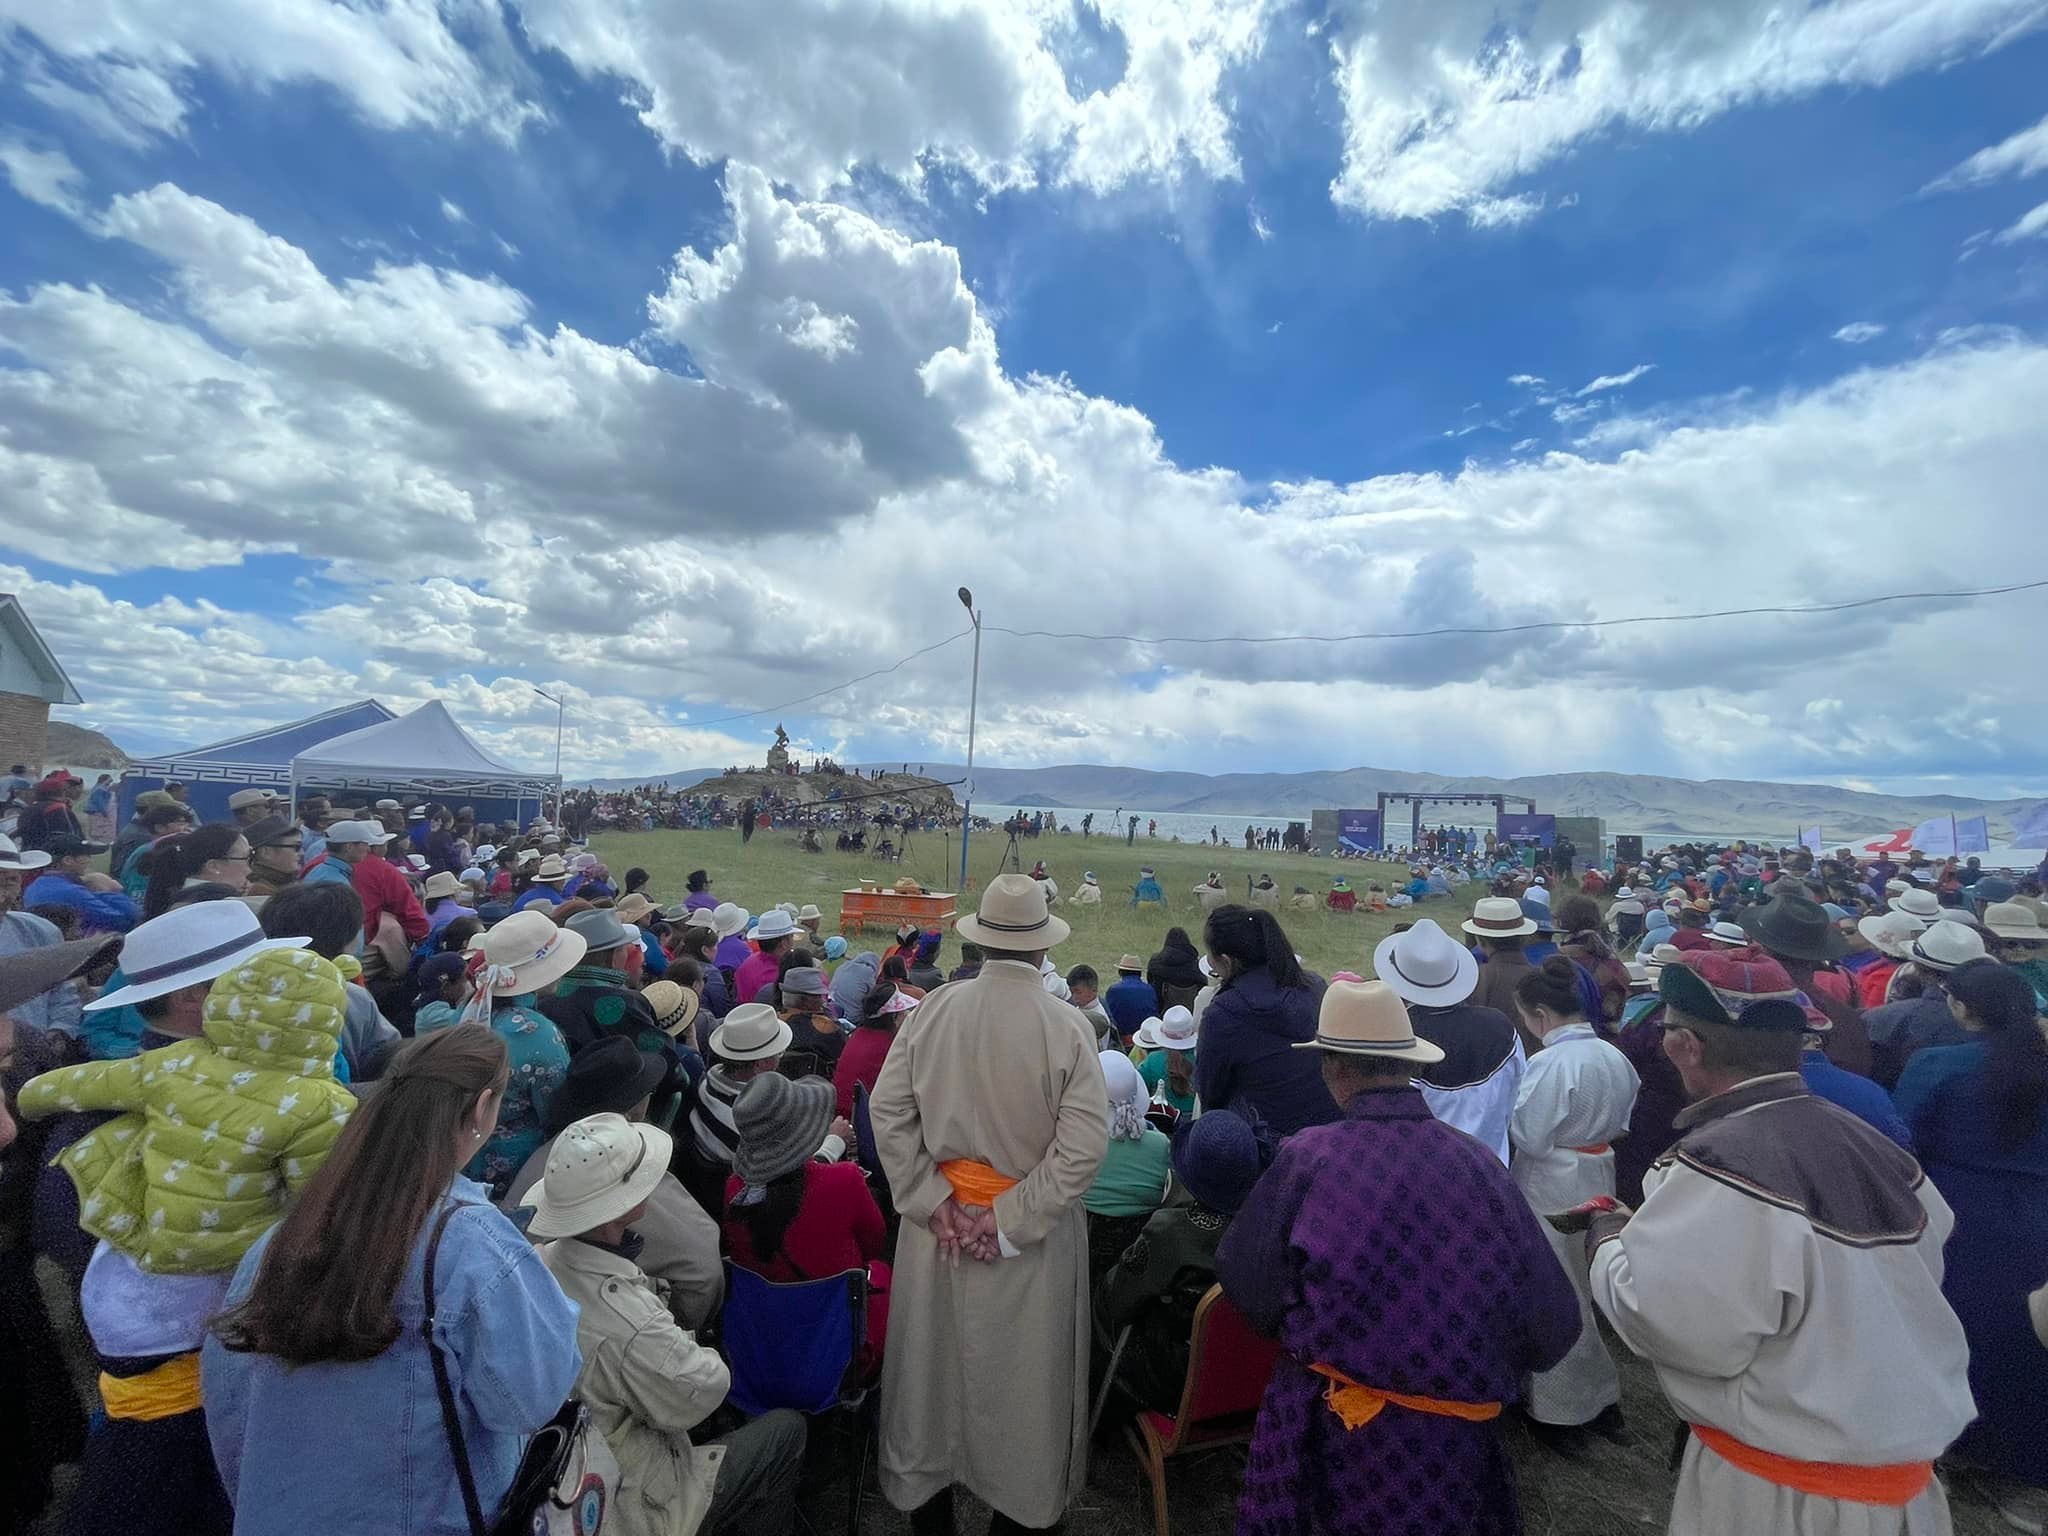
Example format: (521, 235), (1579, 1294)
(592, 762), (2040, 844)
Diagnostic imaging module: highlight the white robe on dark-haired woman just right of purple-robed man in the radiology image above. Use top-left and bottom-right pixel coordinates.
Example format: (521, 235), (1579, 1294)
(1507, 1024), (1642, 1423)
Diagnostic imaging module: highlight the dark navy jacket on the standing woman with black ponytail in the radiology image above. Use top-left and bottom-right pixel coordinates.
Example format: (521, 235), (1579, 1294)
(1187, 967), (1343, 1137)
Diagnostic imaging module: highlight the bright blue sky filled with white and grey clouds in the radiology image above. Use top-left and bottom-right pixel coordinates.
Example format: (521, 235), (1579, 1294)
(0, 0), (2048, 795)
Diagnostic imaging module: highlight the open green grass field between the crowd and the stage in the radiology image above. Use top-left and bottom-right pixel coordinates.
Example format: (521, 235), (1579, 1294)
(592, 829), (1433, 975)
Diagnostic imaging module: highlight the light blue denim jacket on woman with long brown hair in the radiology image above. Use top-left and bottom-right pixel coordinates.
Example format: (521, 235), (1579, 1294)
(201, 1178), (584, 1536)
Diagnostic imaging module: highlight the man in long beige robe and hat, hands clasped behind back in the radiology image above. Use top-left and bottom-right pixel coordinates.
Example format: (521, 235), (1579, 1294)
(872, 874), (1110, 1536)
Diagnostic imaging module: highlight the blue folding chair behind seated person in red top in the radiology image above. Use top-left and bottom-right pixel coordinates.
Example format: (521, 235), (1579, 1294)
(721, 1260), (874, 1536)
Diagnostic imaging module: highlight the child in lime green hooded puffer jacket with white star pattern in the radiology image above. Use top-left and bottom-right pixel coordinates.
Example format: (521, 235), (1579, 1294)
(20, 948), (354, 1274)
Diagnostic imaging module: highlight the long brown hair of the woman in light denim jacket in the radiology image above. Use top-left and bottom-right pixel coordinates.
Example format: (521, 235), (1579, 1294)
(213, 1024), (510, 1366)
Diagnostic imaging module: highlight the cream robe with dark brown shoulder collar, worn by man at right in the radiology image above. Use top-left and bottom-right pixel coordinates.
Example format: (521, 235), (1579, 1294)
(1587, 1073), (1976, 1536)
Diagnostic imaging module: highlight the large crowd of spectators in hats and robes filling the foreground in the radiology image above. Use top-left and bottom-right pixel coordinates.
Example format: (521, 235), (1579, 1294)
(0, 786), (2048, 1536)
